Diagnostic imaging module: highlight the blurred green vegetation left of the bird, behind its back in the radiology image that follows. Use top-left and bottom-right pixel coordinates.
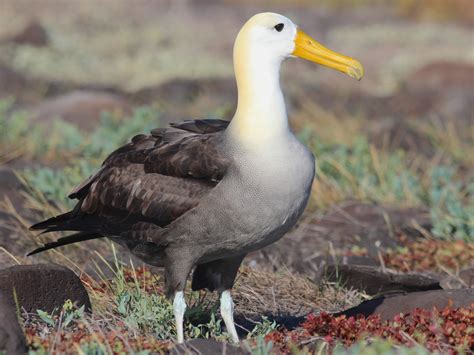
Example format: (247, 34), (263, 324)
(0, 101), (159, 166)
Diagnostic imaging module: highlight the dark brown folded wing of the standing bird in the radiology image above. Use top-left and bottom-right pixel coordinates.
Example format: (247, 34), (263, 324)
(32, 120), (229, 248)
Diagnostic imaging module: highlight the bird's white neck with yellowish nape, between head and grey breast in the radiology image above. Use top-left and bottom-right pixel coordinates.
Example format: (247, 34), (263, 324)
(228, 46), (288, 144)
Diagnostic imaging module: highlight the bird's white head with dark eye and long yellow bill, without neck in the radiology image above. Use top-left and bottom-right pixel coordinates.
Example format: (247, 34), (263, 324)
(234, 12), (364, 80)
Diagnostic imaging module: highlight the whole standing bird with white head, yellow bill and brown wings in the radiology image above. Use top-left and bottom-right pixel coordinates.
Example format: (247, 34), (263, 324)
(29, 12), (364, 343)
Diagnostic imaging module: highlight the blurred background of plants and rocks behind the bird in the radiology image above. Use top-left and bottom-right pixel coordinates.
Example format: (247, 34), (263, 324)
(0, 0), (474, 354)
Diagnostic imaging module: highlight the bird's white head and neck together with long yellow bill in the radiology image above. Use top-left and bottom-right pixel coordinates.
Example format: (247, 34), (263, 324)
(230, 12), (364, 140)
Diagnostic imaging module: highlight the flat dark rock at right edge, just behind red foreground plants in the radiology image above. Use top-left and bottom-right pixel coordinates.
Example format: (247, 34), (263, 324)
(337, 289), (474, 320)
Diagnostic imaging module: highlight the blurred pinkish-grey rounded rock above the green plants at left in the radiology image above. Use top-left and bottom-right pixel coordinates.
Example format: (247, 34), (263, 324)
(31, 90), (132, 130)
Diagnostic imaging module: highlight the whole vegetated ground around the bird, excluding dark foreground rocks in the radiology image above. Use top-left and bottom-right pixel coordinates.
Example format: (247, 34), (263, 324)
(0, 0), (474, 354)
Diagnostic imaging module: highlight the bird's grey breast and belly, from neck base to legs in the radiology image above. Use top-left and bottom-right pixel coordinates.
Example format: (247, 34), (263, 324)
(170, 136), (315, 262)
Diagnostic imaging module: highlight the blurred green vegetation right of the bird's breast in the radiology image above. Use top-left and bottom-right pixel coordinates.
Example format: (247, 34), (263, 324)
(301, 131), (474, 241)
